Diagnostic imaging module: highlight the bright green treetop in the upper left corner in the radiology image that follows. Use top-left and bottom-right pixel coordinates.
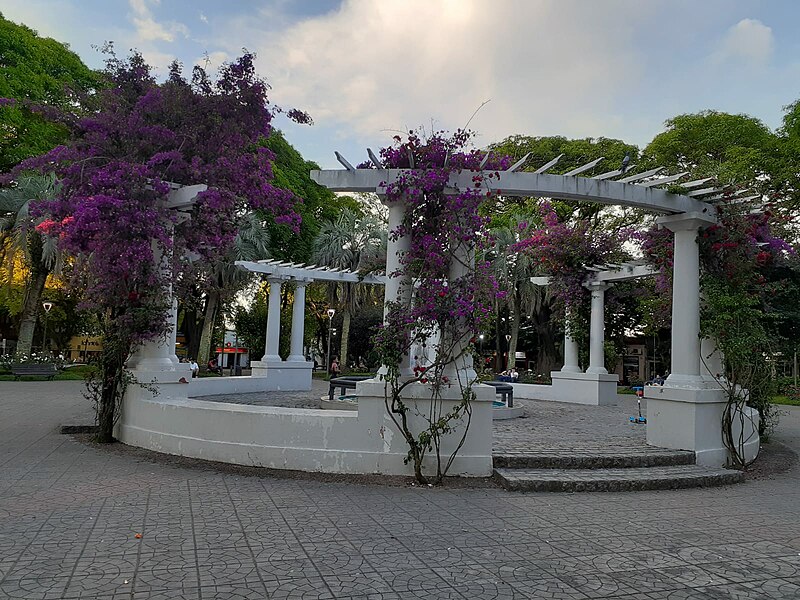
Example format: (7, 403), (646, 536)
(0, 13), (102, 172)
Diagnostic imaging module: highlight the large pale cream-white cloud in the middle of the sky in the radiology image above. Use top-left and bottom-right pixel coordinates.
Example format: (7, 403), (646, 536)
(242, 0), (648, 150)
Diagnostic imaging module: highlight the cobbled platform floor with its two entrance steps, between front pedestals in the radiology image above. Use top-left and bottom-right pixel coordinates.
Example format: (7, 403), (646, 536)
(493, 396), (743, 492)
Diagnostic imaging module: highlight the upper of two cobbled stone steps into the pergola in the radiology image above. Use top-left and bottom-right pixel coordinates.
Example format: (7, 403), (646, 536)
(492, 448), (695, 469)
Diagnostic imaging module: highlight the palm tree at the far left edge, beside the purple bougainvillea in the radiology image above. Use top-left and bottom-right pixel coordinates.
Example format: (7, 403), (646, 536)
(0, 175), (63, 355)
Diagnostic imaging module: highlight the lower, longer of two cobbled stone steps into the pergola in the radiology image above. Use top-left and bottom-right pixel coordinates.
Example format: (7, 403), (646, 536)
(494, 465), (744, 492)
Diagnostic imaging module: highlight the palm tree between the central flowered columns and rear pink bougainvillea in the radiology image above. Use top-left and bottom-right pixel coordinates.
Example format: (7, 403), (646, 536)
(489, 212), (549, 368)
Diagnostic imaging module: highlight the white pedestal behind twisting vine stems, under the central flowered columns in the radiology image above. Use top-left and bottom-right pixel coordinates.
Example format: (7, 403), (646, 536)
(356, 379), (495, 477)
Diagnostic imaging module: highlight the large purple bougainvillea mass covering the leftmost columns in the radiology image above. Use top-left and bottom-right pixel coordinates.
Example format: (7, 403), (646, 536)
(11, 53), (310, 341)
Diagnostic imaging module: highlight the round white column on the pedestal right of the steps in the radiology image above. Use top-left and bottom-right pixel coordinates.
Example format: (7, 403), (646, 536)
(659, 215), (706, 387)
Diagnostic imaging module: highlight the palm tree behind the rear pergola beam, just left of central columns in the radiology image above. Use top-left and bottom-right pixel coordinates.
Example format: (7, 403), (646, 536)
(312, 208), (387, 369)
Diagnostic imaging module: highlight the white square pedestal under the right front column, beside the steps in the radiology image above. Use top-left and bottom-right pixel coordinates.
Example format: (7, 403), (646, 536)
(644, 385), (760, 467)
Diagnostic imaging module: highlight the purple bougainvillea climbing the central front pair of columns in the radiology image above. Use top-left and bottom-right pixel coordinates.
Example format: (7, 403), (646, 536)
(376, 130), (509, 380)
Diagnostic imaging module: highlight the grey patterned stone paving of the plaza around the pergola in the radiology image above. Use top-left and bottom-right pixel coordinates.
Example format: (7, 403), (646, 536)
(0, 382), (800, 600)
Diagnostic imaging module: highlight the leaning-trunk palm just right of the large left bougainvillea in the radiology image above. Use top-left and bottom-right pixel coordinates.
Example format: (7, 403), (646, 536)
(197, 213), (270, 365)
